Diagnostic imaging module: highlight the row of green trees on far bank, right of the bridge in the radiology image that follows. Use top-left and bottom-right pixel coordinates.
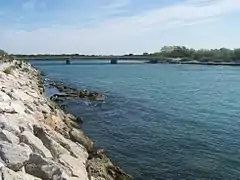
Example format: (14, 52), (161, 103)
(143, 46), (240, 62)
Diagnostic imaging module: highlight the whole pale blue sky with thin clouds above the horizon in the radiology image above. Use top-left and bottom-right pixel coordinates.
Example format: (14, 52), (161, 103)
(0, 0), (240, 55)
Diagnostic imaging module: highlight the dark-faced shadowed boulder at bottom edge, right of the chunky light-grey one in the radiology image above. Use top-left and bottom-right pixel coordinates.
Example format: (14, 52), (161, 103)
(25, 154), (71, 180)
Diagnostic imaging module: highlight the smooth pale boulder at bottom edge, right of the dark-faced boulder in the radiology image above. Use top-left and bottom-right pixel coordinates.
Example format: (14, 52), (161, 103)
(59, 154), (88, 180)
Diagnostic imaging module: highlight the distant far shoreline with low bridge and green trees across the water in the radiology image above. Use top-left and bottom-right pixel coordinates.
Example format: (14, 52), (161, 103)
(7, 46), (240, 66)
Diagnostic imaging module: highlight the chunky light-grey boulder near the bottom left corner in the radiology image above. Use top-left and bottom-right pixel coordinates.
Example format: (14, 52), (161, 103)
(0, 141), (32, 171)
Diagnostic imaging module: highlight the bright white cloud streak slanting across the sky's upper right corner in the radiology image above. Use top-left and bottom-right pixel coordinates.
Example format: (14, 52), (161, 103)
(121, 0), (240, 27)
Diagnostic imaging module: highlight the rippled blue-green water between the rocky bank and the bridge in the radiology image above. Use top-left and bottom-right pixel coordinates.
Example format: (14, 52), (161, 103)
(33, 62), (240, 180)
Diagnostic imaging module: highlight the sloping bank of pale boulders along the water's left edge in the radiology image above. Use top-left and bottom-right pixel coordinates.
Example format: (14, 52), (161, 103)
(0, 60), (132, 180)
